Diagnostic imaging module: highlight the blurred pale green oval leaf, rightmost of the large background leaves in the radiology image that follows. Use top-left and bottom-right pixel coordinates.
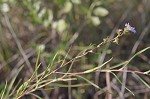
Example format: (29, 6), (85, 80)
(93, 7), (109, 17)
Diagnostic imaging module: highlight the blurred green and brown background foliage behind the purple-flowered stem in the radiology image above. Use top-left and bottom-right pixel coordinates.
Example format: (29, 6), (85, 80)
(0, 0), (150, 99)
